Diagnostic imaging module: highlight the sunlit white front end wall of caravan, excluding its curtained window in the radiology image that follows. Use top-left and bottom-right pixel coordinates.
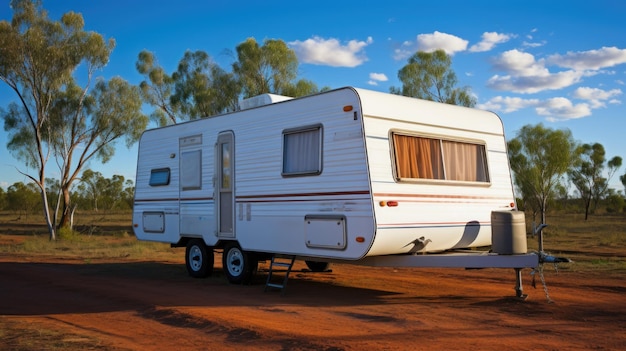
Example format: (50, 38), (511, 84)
(359, 90), (515, 255)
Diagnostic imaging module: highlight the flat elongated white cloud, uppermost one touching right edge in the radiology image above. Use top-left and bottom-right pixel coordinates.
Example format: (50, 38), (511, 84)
(547, 46), (626, 70)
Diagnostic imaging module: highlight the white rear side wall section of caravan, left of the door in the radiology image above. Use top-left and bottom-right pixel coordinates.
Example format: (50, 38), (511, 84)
(133, 123), (216, 243)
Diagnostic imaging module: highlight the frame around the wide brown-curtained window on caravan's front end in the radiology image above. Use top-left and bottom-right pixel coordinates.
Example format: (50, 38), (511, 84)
(389, 130), (491, 187)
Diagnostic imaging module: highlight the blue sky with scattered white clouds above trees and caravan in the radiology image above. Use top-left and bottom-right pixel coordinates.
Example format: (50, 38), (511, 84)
(0, 0), (626, 190)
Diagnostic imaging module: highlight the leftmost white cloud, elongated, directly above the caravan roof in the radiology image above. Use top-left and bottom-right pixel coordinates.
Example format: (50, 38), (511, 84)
(288, 36), (374, 67)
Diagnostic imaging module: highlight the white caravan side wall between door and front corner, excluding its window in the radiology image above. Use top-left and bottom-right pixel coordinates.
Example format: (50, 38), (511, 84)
(234, 89), (375, 259)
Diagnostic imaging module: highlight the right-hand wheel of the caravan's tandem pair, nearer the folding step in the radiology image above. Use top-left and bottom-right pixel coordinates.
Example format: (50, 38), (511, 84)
(222, 243), (259, 284)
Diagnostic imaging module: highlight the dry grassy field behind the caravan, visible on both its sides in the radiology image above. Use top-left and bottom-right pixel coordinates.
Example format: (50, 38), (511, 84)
(0, 212), (626, 273)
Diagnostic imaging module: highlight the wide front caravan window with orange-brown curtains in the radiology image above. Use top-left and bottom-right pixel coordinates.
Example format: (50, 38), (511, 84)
(392, 133), (489, 183)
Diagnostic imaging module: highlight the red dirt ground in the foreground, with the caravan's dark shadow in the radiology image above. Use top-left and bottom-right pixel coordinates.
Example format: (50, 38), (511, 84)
(0, 249), (626, 350)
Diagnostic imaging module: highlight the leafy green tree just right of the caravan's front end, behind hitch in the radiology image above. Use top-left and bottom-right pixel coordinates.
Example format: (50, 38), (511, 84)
(507, 124), (578, 224)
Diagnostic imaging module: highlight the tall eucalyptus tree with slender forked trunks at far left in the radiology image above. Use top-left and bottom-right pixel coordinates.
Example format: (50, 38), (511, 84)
(0, 0), (147, 240)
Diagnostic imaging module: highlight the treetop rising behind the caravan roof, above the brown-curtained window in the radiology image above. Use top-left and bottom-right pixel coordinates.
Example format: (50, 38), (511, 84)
(390, 50), (476, 107)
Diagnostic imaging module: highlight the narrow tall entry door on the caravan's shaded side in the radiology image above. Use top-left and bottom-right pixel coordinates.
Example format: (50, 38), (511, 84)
(215, 131), (235, 238)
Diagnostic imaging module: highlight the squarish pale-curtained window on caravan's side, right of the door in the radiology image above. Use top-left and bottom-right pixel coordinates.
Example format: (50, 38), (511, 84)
(282, 125), (322, 176)
